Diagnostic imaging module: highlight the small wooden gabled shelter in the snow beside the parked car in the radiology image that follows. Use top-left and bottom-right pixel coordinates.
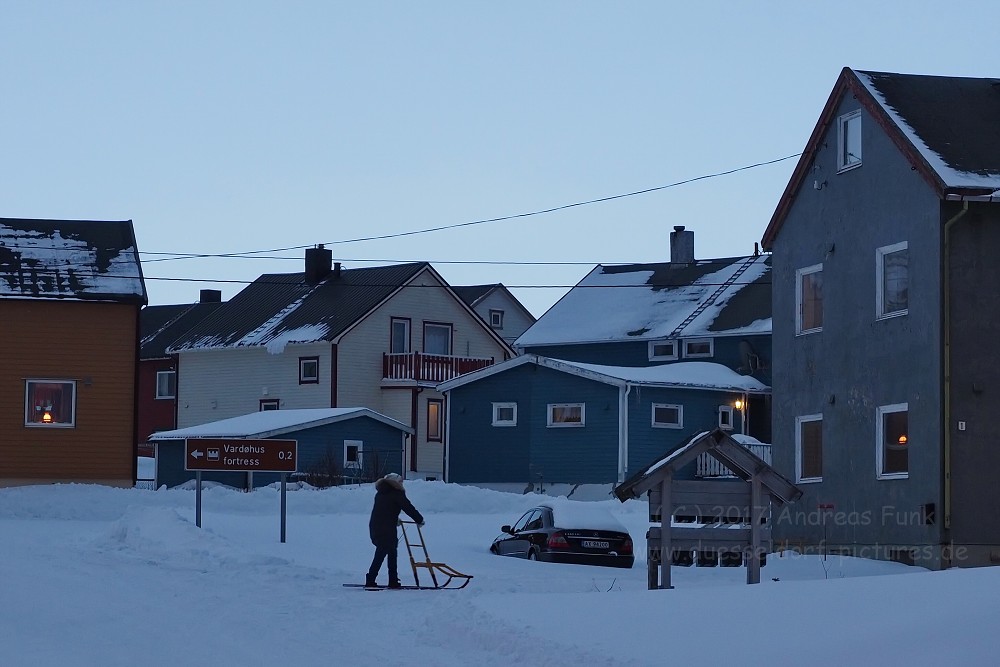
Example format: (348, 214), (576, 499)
(615, 429), (802, 590)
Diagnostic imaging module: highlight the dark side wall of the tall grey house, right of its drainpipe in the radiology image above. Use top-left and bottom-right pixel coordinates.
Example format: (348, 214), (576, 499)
(942, 203), (1000, 565)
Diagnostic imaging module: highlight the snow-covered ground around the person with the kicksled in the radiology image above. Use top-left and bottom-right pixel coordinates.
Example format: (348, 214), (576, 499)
(0, 472), (1000, 667)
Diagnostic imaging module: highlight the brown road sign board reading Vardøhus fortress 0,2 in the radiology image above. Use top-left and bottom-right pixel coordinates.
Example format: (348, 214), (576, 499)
(184, 438), (299, 472)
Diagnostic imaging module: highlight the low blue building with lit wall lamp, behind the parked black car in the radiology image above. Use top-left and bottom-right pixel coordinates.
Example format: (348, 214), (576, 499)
(438, 354), (770, 486)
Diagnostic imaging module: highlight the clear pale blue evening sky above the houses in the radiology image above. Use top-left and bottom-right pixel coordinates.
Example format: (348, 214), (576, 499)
(0, 0), (1000, 316)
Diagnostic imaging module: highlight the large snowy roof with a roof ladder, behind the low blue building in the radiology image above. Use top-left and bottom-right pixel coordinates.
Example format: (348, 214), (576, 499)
(514, 255), (771, 348)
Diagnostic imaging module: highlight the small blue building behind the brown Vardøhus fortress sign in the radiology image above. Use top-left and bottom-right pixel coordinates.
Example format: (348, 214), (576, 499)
(150, 408), (413, 488)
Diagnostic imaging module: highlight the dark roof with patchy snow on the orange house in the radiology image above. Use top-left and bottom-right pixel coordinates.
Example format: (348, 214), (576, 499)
(0, 218), (146, 304)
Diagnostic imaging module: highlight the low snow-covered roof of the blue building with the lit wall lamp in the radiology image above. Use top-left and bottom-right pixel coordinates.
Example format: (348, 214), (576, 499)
(437, 354), (770, 394)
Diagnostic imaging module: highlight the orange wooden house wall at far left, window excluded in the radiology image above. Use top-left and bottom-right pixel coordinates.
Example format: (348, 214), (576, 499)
(0, 299), (139, 486)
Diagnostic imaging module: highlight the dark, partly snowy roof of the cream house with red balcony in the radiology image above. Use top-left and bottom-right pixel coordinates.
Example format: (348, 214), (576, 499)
(167, 262), (430, 353)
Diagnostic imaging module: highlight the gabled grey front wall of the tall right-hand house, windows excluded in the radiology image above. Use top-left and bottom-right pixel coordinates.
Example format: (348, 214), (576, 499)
(772, 91), (942, 566)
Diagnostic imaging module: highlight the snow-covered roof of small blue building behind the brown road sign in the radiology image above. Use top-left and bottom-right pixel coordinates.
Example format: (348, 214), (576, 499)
(149, 408), (413, 441)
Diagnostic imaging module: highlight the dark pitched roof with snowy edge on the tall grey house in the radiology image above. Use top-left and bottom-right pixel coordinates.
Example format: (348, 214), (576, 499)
(762, 67), (1000, 250)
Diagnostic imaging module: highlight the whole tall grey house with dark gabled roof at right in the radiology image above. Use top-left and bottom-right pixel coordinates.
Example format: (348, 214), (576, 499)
(763, 69), (1000, 568)
